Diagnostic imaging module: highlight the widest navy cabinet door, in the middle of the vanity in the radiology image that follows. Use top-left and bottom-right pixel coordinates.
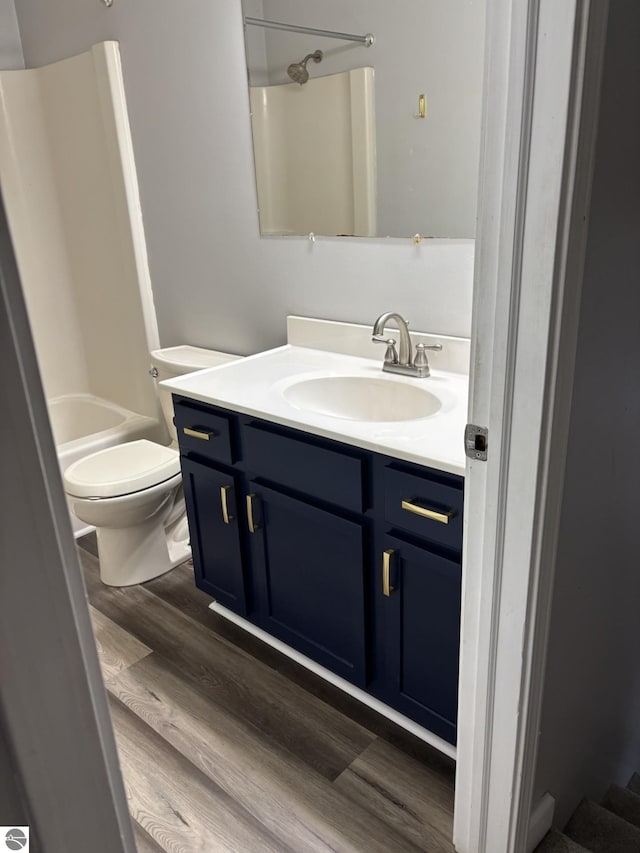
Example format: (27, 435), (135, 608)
(248, 483), (366, 685)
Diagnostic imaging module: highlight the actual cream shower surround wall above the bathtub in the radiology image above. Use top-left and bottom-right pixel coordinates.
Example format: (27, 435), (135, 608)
(0, 42), (166, 430)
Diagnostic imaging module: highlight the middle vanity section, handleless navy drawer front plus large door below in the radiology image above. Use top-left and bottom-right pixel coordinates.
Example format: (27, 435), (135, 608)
(242, 421), (370, 686)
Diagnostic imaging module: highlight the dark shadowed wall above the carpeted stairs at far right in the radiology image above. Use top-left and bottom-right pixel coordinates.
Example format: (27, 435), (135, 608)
(536, 0), (640, 826)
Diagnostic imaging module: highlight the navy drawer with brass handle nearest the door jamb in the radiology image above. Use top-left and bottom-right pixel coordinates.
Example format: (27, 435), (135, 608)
(384, 467), (463, 551)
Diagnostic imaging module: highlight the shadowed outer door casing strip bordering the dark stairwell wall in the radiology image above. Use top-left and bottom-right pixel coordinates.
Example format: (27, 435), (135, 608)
(512, 0), (609, 849)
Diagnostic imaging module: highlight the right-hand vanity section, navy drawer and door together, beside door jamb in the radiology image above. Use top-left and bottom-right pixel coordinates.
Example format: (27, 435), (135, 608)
(376, 463), (463, 743)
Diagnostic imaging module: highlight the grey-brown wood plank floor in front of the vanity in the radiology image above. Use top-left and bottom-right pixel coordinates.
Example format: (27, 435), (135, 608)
(79, 536), (454, 853)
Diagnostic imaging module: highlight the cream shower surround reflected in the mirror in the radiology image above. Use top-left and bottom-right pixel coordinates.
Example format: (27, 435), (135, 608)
(250, 68), (377, 237)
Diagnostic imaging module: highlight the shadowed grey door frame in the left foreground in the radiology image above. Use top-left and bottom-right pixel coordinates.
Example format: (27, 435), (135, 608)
(0, 190), (135, 853)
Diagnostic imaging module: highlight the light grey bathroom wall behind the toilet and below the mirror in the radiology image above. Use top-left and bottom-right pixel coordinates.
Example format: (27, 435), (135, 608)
(13, 0), (473, 354)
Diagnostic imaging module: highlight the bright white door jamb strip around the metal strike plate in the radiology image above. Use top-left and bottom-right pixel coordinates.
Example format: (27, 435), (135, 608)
(453, 0), (526, 840)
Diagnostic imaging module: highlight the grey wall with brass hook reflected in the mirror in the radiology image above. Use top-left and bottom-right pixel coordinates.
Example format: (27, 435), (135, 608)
(255, 0), (485, 237)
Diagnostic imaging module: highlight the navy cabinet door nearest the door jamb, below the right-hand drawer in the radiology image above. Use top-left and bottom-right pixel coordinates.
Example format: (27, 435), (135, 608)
(376, 536), (461, 743)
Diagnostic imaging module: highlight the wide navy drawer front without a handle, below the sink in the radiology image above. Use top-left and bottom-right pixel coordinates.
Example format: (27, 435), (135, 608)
(243, 424), (364, 512)
